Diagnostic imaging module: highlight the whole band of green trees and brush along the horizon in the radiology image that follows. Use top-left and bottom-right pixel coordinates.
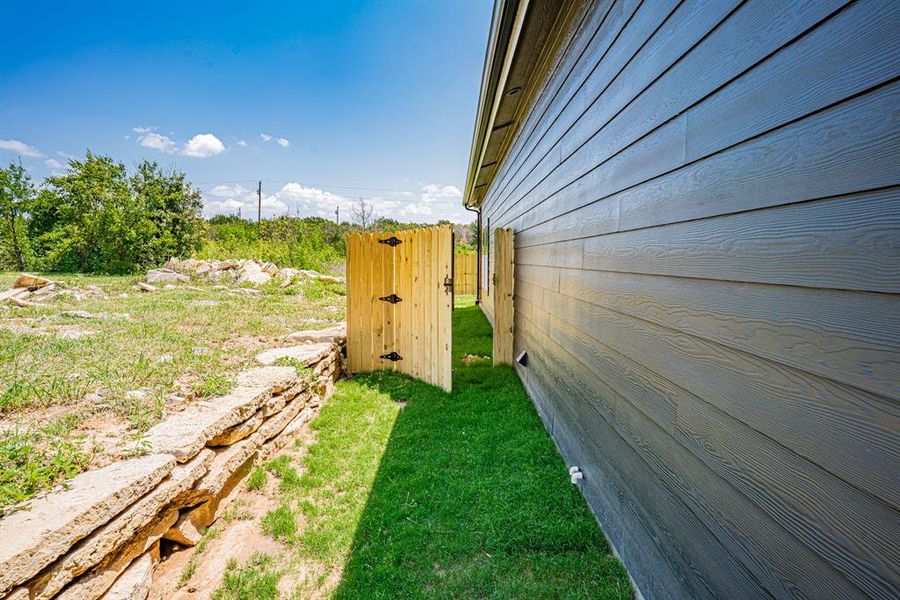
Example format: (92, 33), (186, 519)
(0, 152), (475, 273)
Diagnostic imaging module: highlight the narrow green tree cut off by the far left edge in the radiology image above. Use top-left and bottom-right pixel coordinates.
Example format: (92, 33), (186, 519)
(0, 160), (34, 271)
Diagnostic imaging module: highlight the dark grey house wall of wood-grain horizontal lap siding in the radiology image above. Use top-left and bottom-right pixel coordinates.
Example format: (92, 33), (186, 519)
(482, 0), (900, 598)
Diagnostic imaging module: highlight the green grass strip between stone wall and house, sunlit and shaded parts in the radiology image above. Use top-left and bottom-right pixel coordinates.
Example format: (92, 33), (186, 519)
(239, 303), (632, 598)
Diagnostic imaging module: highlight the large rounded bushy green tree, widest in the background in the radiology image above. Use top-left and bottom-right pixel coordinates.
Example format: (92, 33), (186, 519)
(29, 152), (205, 273)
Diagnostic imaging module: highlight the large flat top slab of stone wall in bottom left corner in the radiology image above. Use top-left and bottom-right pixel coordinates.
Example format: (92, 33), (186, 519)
(0, 454), (175, 593)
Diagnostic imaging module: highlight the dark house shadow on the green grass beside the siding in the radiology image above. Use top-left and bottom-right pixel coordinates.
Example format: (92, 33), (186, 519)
(336, 306), (631, 598)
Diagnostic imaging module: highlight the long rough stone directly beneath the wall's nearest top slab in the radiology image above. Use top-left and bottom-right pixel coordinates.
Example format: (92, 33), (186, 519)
(30, 450), (215, 600)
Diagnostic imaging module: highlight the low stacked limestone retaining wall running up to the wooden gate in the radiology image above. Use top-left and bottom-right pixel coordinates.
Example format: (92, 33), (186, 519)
(0, 339), (343, 600)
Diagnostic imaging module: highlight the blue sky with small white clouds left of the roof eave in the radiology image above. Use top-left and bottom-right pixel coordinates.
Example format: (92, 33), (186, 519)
(0, 0), (491, 222)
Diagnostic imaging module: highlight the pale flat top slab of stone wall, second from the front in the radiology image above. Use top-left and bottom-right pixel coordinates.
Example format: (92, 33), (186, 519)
(143, 367), (297, 462)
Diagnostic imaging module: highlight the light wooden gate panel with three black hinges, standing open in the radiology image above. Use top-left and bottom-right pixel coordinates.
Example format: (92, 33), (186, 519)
(347, 226), (453, 391)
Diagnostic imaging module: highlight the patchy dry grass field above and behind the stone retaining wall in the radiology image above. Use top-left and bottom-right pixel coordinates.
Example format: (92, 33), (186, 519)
(0, 273), (344, 508)
